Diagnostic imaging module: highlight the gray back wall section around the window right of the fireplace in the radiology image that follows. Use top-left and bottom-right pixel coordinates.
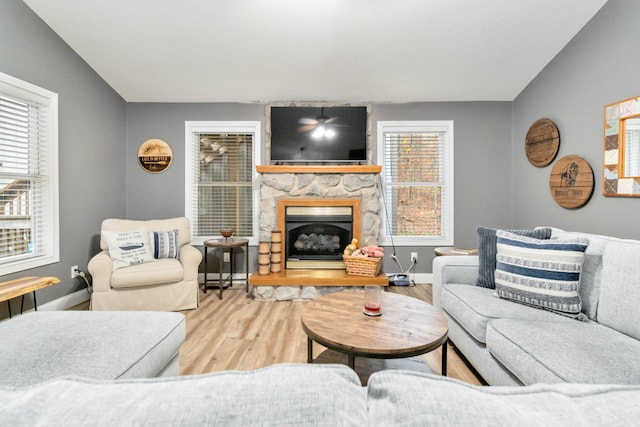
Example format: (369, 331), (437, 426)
(372, 102), (513, 273)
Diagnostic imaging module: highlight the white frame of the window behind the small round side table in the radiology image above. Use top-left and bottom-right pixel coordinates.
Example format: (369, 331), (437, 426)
(185, 121), (262, 246)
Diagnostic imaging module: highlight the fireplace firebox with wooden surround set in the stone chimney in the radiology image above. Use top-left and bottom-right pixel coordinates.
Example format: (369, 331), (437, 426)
(278, 199), (360, 269)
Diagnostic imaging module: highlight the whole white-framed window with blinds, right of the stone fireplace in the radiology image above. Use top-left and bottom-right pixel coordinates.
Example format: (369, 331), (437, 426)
(377, 121), (453, 246)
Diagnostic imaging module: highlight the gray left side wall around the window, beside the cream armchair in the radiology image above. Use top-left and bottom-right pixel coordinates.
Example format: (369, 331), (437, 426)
(0, 0), (126, 317)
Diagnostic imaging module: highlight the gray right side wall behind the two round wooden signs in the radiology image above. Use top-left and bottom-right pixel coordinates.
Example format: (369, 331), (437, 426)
(511, 0), (640, 239)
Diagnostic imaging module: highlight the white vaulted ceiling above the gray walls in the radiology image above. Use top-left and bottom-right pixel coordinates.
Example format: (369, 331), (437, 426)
(24, 0), (606, 102)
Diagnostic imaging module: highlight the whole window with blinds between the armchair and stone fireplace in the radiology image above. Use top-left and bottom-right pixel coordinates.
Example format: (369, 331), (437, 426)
(185, 122), (261, 244)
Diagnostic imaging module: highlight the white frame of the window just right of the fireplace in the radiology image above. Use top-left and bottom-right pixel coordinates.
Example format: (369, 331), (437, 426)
(376, 120), (454, 247)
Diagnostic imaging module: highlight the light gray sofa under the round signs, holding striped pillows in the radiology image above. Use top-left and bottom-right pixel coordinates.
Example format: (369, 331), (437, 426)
(433, 229), (640, 385)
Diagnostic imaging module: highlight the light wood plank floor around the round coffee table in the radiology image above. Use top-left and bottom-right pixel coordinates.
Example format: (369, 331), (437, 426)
(180, 285), (484, 385)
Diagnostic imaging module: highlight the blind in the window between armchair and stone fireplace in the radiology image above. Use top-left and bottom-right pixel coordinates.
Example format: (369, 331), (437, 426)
(191, 132), (254, 237)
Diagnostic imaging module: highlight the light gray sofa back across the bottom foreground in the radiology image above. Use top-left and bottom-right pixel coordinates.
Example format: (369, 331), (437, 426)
(0, 364), (640, 426)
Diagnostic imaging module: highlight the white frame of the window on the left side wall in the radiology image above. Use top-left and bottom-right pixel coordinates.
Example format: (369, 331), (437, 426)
(0, 72), (60, 275)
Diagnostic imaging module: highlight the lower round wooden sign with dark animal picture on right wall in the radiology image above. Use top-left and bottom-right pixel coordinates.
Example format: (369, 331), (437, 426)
(549, 155), (593, 209)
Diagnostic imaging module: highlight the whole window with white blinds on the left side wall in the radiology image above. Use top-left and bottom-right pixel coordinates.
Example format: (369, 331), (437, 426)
(0, 73), (60, 275)
